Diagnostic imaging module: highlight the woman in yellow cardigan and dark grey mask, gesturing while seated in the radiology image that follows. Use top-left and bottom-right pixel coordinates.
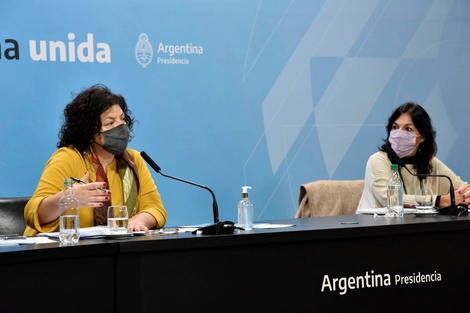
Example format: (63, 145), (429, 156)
(25, 85), (166, 236)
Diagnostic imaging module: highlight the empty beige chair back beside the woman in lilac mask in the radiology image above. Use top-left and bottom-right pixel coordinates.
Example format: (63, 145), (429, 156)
(295, 180), (364, 218)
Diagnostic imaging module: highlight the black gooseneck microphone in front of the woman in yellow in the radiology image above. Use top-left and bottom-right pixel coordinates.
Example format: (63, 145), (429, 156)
(140, 151), (241, 235)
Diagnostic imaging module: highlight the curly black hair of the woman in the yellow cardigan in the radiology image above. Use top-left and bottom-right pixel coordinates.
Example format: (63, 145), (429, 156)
(57, 84), (134, 154)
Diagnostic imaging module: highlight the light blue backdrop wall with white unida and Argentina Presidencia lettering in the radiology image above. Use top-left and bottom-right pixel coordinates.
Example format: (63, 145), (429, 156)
(0, 0), (470, 225)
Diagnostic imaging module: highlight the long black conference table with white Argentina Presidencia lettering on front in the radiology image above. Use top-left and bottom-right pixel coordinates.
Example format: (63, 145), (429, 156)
(0, 214), (470, 313)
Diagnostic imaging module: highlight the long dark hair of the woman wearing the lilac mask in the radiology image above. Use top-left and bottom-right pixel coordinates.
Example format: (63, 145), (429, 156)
(384, 102), (437, 174)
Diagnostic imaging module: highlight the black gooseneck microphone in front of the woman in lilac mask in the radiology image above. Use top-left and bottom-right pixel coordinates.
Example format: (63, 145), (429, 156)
(382, 144), (468, 216)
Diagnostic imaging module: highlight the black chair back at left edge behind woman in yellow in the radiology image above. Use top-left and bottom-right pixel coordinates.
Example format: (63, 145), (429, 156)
(0, 197), (29, 235)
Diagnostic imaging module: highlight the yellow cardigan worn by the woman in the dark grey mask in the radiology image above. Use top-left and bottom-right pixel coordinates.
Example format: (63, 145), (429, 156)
(24, 147), (166, 236)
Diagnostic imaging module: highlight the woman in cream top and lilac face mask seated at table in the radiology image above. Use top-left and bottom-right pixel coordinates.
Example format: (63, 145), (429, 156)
(357, 102), (470, 213)
